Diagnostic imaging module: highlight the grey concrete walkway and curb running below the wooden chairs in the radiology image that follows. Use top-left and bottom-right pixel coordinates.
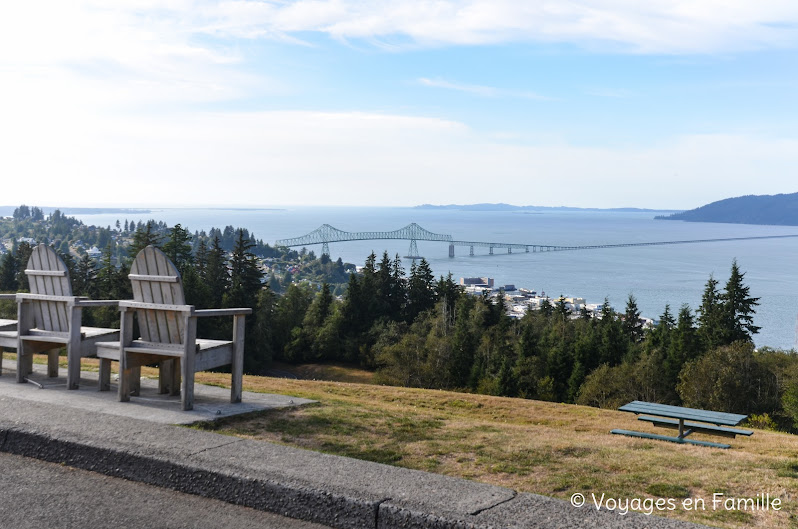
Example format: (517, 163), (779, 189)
(0, 369), (708, 529)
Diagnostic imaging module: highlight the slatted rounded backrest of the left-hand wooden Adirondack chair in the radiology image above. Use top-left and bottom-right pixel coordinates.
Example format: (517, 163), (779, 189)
(25, 244), (72, 332)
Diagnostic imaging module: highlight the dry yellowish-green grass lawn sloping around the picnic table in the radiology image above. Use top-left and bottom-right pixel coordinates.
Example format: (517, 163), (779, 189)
(7, 355), (798, 529)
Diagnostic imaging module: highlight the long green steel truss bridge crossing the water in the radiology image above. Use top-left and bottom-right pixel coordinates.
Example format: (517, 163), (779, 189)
(275, 222), (798, 259)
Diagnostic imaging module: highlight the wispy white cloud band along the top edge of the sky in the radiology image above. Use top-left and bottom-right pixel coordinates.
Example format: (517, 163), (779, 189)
(206, 0), (798, 54)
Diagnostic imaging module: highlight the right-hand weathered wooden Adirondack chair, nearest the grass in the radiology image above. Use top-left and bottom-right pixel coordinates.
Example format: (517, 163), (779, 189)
(97, 246), (252, 410)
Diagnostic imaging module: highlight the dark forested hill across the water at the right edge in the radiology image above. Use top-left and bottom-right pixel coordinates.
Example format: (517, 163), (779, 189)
(655, 193), (798, 226)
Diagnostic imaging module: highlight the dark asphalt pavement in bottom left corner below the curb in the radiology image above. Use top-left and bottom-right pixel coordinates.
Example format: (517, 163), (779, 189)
(0, 453), (327, 529)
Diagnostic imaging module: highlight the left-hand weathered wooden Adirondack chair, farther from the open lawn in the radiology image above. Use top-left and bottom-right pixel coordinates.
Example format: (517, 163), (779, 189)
(16, 244), (119, 389)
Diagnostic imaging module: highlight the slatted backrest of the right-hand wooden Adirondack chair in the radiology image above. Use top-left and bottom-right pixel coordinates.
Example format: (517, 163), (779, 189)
(128, 246), (186, 344)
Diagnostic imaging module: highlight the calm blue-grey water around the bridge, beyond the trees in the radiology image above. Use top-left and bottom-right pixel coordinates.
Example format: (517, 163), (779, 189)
(77, 207), (798, 349)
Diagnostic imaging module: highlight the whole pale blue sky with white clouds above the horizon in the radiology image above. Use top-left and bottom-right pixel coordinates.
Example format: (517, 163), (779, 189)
(0, 0), (798, 209)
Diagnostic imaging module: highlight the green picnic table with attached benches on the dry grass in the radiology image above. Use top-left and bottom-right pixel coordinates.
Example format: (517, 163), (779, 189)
(610, 400), (754, 448)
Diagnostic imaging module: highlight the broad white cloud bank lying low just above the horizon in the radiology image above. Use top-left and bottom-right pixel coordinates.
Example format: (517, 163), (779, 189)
(0, 112), (798, 208)
